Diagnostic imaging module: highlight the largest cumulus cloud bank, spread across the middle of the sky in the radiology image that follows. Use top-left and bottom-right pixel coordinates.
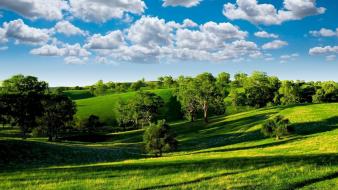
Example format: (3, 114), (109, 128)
(85, 16), (261, 63)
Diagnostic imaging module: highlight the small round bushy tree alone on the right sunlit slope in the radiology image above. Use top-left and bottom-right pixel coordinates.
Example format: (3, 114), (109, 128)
(261, 115), (294, 140)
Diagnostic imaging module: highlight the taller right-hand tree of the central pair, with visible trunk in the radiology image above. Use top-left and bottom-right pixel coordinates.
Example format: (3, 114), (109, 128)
(194, 73), (221, 123)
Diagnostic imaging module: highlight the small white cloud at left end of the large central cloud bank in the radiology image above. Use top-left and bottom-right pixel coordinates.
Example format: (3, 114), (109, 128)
(85, 30), (124, 49)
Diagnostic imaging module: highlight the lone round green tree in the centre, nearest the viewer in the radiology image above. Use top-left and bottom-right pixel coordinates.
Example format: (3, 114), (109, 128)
(143, 120), (178, 157)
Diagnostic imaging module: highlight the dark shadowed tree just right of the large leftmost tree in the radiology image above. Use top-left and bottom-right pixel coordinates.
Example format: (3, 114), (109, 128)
(40, 95), (76, 141)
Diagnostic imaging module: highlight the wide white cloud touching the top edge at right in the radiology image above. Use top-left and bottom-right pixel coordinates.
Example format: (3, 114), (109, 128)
(223, 0), (326, 25)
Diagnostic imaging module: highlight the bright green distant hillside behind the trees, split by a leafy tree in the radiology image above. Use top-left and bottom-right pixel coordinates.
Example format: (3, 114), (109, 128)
(76, 89), (184, 125)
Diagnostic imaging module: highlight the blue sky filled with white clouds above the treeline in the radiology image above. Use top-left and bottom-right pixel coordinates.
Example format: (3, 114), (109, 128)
(0, 0), (338, 86)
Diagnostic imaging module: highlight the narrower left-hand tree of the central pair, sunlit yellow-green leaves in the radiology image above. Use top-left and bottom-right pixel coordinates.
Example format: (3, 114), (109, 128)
(176, 76), (199, 122)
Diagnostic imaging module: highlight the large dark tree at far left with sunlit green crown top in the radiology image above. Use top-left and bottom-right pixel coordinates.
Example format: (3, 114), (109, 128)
(2, 75), (48, 139)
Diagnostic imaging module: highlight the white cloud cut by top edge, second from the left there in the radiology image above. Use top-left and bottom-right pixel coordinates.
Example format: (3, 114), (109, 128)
(70, 0), (146, 23)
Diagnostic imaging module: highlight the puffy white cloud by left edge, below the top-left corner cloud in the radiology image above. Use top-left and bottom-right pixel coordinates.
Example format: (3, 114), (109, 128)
(3, 19), (51, 44)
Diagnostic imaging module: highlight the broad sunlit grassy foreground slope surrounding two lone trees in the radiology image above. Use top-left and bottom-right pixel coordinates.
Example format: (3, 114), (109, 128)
(0, 104), (338, 190)
